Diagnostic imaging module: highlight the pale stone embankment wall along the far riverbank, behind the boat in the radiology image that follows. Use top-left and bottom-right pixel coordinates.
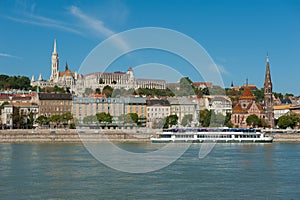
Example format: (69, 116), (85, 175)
(0, 129), (300, 143)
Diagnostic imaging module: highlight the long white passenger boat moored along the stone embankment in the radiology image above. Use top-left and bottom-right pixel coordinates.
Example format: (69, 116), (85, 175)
(151, 128), (273, 142)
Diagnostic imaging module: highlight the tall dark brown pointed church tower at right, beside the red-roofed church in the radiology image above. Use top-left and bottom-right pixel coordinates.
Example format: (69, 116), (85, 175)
(264, 54), (274, 128)
